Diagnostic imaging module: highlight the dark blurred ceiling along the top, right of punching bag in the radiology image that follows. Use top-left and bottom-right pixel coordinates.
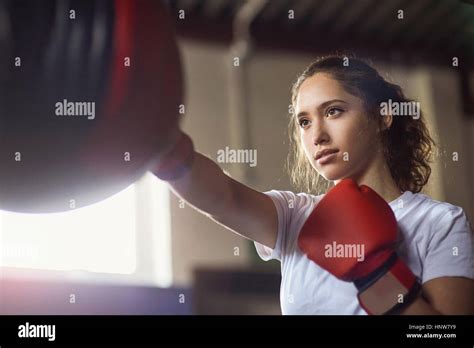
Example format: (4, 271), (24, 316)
(167, 0), (474, 67)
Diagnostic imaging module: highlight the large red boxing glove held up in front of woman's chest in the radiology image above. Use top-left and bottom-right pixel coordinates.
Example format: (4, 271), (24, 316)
(298, 179), (420, 314)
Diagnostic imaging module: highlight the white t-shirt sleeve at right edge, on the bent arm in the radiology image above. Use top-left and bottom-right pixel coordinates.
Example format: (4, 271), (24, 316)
(422, 207), (474, 283)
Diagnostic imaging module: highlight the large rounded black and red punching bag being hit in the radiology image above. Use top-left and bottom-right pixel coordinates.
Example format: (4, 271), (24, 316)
(0, 0), (183, 213)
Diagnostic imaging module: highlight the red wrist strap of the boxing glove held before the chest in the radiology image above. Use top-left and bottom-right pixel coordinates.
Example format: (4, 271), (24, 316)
(354, 253), (421, 315)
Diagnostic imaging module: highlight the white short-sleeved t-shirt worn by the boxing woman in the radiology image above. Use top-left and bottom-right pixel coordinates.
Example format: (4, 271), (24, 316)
(255, 190), (474, 315)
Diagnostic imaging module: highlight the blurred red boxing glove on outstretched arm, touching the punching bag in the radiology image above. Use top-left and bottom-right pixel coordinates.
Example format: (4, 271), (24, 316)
(151, 131), (194, 181)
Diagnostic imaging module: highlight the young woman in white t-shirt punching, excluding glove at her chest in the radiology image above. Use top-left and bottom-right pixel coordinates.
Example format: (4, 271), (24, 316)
(155, 56), (474, 315)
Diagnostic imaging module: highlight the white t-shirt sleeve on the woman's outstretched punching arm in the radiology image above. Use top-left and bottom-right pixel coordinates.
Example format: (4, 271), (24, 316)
(254, 190), (297, 261)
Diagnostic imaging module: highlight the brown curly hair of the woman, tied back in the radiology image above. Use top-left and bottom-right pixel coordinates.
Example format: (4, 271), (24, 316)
(287, 55), (436, 194)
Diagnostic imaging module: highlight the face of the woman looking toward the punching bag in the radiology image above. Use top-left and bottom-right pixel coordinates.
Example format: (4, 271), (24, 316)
(295, 73), (380, 181)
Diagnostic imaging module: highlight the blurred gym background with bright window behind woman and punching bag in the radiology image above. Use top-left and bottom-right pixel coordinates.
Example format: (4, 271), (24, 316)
(0, 0), (474, 315)
